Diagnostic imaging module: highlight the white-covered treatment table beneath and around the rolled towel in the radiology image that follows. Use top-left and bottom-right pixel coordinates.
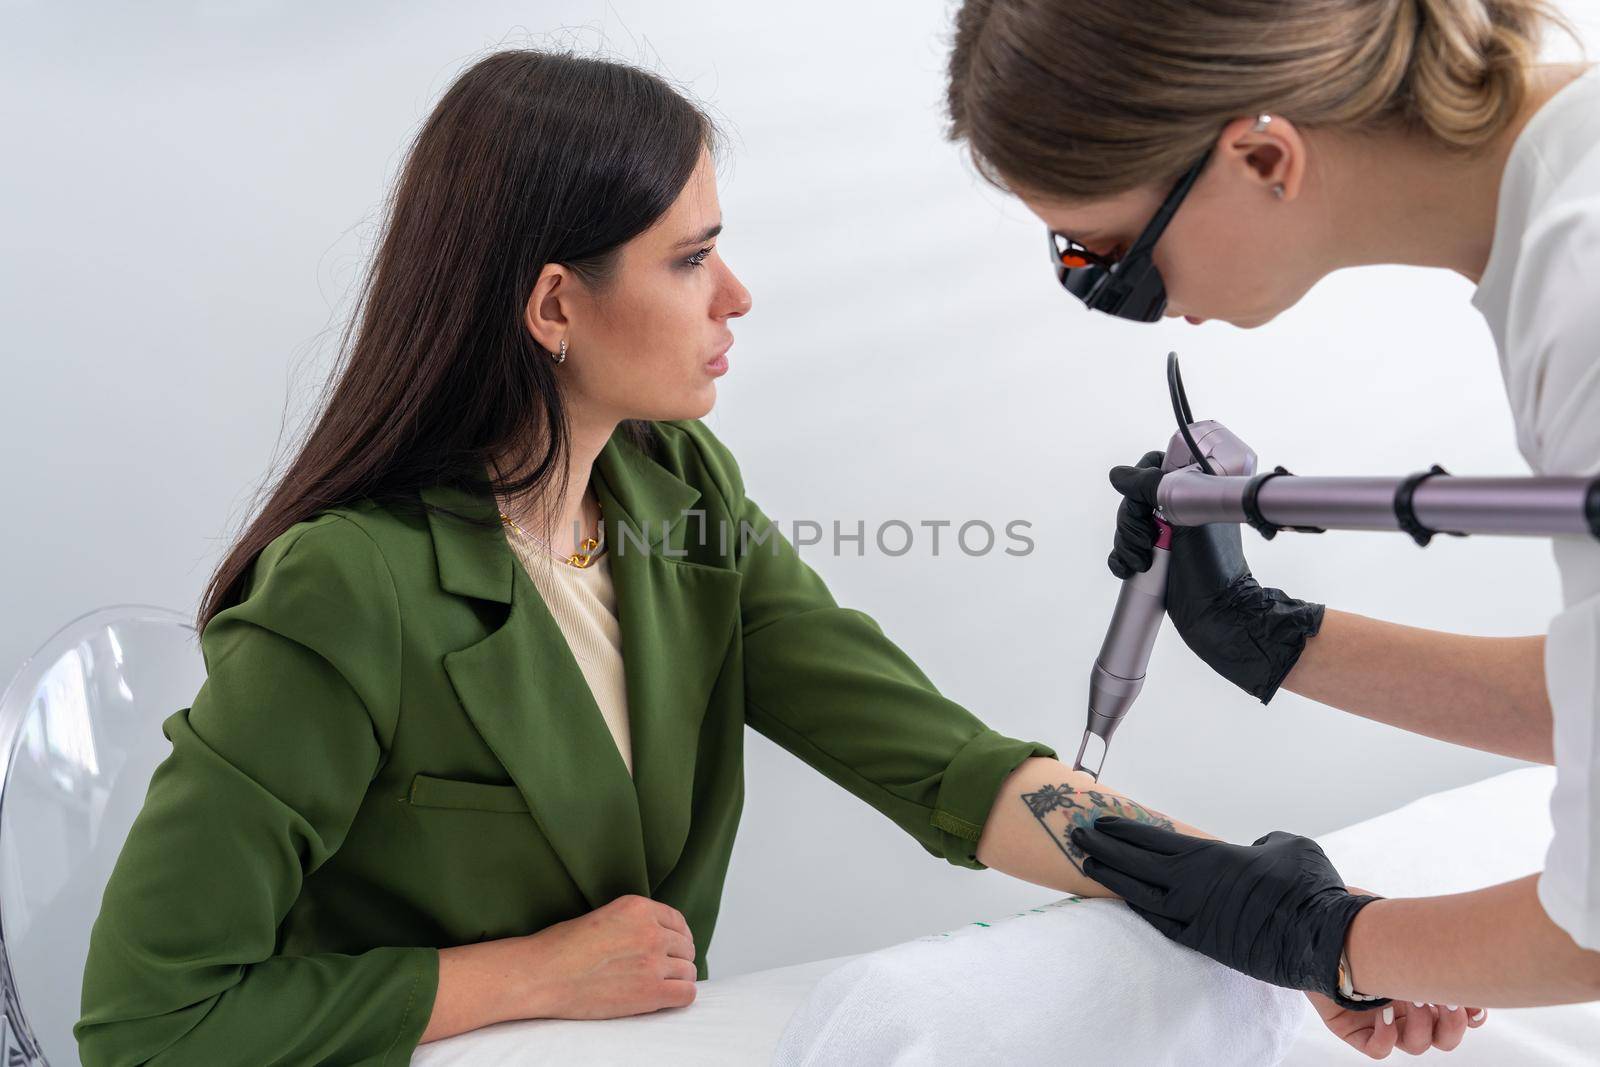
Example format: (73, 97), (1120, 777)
(411, 768), (1600, 1067)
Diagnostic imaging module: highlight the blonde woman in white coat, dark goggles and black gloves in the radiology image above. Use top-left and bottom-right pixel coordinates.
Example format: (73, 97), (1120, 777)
(949, 0), (1600, 1030)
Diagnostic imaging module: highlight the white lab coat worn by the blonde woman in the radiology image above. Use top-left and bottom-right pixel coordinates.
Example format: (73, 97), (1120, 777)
(1472, 66), (1600, 950)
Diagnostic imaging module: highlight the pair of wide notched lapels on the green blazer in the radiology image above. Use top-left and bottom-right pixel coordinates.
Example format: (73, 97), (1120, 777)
(421, 434), (739, 907)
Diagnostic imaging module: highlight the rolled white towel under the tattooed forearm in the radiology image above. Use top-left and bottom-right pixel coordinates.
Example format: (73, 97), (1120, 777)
(773, 896), (1315, 1067)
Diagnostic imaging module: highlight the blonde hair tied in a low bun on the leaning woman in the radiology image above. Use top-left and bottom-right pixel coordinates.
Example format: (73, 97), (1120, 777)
(946, 0), (1581, 200)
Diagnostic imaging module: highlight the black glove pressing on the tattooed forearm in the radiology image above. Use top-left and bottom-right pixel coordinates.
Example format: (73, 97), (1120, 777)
(1072, 816), (1389, 1011)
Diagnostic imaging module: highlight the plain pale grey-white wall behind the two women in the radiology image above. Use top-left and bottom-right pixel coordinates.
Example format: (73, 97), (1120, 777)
(0, 0), (1600, 977)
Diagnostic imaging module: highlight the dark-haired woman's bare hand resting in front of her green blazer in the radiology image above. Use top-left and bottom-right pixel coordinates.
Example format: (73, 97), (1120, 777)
(518, 894), (694, 1019)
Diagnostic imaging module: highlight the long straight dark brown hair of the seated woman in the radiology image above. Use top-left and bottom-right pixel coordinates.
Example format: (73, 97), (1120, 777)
(195, 48), (720, 632)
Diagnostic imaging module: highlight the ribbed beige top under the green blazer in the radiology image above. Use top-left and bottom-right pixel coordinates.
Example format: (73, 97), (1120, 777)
(506, 530), (634, 776)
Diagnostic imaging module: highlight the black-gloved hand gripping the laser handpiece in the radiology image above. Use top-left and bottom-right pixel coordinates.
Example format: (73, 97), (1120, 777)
(1106, 451), (1323, 704)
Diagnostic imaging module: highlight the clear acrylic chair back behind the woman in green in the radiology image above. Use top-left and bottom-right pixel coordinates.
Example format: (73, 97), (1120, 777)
(0, 605), (205, 1067)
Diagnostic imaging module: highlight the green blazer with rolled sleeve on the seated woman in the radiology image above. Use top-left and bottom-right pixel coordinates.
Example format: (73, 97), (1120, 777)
(74, 419), (1056, 1067)
